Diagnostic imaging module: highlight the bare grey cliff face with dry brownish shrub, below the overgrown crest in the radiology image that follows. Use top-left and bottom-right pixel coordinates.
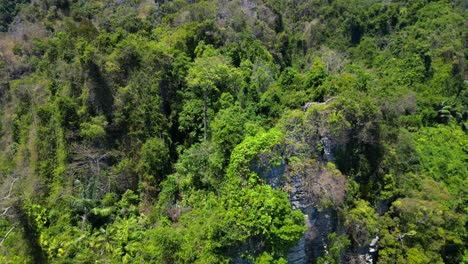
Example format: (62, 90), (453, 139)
(257, 158), (345, 264)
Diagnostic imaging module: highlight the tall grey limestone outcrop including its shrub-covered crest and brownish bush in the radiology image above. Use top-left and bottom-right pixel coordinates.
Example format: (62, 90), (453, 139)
(258, 98), (356, 264)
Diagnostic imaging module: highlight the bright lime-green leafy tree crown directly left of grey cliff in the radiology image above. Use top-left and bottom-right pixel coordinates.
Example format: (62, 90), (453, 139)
(146, 186), (304, 263)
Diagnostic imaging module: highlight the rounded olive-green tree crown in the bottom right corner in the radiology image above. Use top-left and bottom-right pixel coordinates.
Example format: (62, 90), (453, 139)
(379, 179), (466, 263)
